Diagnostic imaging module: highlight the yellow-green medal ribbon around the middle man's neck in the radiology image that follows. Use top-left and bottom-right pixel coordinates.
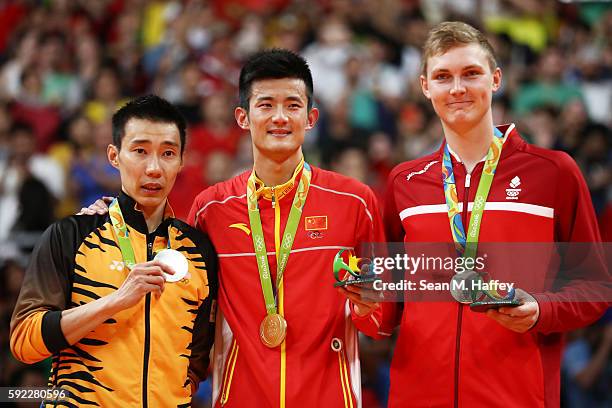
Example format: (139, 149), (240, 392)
(247, 161), (312, 315)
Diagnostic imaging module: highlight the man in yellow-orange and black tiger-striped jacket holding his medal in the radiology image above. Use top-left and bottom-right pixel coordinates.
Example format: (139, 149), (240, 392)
(10, 96), (217, 407)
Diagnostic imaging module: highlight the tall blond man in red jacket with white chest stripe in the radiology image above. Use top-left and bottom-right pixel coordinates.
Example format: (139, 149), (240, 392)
(346, 22), (610, 407)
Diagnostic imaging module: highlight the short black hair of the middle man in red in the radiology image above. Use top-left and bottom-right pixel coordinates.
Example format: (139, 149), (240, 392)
(238, 48), (313, 111)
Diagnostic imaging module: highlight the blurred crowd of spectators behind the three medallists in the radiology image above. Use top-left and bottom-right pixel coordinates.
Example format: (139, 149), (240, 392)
(0, 0), (612, 407)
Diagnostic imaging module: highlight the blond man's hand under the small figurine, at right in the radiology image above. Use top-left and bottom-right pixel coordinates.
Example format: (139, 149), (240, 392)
(487, 289), (540, 333)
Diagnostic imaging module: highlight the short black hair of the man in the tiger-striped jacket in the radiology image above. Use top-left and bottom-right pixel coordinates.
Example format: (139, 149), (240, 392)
(113, 95), (187, 156)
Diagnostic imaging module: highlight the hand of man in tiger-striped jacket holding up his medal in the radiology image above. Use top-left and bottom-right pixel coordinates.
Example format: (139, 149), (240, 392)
(111, 261), (174, 310)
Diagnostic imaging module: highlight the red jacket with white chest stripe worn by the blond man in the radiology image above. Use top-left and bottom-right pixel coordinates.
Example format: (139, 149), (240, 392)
(353, 126), (610, 407)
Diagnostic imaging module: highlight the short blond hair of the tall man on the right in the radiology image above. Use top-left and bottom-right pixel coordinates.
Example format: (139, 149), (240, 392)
(421, 21), (497, 76)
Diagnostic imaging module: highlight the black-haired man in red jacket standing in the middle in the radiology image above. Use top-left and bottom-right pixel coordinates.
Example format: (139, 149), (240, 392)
(189, 50), (384, 408)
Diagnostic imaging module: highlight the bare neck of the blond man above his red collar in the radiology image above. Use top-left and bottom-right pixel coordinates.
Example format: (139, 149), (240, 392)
(442, 110), (494, 173)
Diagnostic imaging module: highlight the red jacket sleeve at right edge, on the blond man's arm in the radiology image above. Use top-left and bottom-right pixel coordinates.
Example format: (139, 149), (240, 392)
(533, 153), (611, 334)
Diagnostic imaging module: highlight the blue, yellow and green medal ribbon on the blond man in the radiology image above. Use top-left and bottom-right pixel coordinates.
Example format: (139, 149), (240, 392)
(442, 128), (506, 259)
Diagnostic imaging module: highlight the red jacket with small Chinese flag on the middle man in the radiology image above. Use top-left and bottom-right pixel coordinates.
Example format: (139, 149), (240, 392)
(189, 168), (383, 407)
